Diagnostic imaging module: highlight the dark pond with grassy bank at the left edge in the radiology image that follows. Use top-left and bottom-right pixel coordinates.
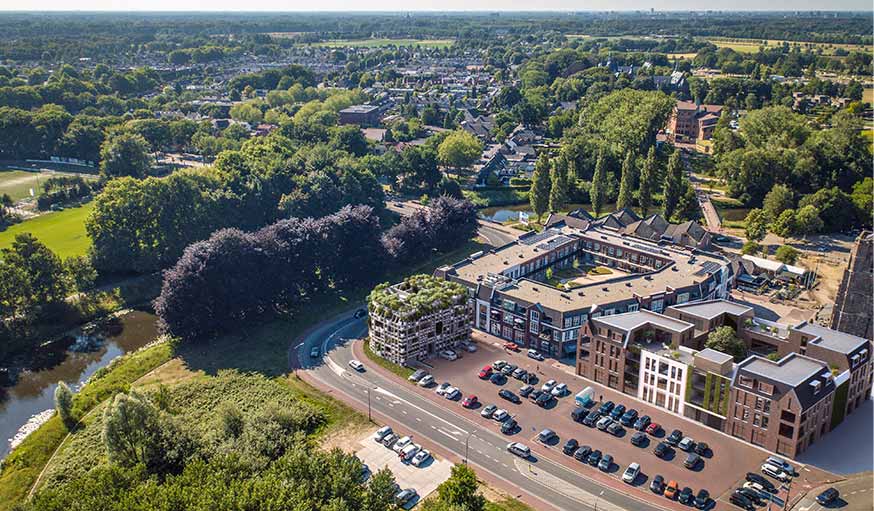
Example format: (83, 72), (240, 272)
(0, 311), (158, 459)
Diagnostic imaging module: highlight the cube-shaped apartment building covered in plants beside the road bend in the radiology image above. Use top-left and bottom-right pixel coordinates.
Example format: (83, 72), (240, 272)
(367, 275), (471, 365)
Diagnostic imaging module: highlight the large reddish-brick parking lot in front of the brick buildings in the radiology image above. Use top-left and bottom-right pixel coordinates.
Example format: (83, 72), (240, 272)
(408, 332), (827, 508)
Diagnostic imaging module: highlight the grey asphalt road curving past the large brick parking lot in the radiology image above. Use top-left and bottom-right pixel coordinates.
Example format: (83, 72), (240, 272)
(289, 314), (662, 511)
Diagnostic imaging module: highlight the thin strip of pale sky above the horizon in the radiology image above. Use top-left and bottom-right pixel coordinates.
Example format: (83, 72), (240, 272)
(6, 0), (872, 12)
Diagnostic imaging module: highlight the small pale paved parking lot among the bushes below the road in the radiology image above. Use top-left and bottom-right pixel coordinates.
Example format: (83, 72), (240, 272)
(355, 431), (452, 509)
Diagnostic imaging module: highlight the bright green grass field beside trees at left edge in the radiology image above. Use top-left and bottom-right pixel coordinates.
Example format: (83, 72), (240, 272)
(0, 202), (94, 258)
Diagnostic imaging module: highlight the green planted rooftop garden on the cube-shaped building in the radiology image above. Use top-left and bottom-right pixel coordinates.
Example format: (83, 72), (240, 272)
(367, 274), (467, 320)
